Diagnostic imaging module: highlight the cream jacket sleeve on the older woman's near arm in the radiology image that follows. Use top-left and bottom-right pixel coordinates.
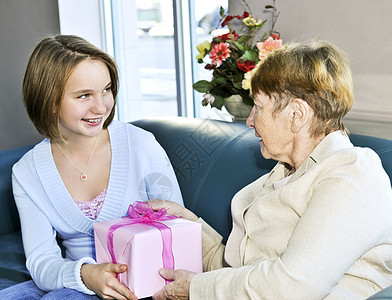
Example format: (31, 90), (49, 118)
(190, 150), (392, 299)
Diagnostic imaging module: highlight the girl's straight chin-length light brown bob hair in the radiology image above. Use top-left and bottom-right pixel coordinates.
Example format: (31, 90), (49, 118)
(22, 35), (118, 140)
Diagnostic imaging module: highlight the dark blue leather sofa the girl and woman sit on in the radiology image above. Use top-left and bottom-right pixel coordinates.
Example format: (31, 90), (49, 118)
(0, 117), (392, 299)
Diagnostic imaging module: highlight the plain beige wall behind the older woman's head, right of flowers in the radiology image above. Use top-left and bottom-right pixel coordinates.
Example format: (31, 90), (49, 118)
(229, 0), (392, 123)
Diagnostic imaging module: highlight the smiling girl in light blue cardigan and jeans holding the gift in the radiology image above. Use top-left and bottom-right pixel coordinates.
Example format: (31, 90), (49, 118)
(0, 35), (183, 299)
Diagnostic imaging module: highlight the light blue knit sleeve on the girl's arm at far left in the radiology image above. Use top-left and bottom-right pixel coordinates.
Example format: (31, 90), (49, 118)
(12, 175), (95, 295)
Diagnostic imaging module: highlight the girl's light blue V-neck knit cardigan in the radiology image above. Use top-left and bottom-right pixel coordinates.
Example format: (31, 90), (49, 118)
(12, 122), (183, 294)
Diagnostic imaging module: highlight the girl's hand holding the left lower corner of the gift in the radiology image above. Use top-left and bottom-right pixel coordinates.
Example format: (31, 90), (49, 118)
(80, 263), (137, 300)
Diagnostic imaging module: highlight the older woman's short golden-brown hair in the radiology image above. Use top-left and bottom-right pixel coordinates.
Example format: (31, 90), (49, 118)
(251, 40), (354, 136)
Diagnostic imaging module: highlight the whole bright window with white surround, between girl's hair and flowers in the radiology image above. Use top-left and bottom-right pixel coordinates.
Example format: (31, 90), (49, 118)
(58, 0), (230, 121)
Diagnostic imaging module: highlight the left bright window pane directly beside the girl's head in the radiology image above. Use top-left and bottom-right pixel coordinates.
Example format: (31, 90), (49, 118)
(111, 0), (178, 121)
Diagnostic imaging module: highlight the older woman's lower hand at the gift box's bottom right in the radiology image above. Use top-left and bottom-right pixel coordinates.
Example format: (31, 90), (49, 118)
(152, 269), (196, 300)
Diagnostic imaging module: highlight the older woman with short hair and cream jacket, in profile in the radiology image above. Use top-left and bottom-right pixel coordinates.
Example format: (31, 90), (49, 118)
(151, 41), (392, 300)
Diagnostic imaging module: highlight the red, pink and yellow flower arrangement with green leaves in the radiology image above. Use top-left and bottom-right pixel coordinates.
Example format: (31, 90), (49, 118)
(193, 0), (282, 109)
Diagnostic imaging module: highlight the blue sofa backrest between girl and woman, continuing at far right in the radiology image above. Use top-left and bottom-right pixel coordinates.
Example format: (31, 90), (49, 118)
(133, 117), (392, 241)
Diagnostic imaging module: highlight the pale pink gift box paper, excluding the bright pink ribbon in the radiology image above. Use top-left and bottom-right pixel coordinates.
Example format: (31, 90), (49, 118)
(94, 218), (203, 298)
